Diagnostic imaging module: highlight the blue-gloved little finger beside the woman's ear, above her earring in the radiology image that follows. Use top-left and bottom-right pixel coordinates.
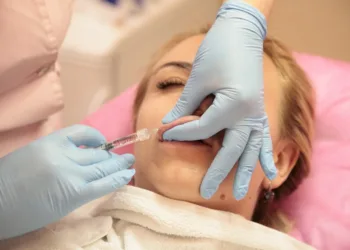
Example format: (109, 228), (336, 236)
(259, 120), (277, 180)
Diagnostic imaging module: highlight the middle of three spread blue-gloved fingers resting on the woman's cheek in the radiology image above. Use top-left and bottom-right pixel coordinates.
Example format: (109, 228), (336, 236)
(233, 130), (262, 200)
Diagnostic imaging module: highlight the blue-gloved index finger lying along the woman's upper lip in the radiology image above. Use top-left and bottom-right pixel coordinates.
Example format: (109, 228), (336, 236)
(163, 99), (225, 141)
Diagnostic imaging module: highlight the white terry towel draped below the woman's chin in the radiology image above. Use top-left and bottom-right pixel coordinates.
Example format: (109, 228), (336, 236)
(0, 186), (314, 250)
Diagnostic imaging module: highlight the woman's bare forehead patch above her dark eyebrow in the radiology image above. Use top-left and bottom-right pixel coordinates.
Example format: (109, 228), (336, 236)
(155, 35), (204, 67)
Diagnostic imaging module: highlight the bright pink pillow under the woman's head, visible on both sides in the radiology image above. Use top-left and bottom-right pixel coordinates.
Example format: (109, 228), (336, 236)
(83, 53), (350, 250)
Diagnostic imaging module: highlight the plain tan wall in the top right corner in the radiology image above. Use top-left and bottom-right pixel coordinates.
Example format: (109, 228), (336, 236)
(268, 0), (350, 61)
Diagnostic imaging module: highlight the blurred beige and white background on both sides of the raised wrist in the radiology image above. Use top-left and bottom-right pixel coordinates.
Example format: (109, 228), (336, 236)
(59, 0), (350, 125)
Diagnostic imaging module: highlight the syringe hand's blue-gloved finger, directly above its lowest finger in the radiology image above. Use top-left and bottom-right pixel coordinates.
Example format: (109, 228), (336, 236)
(83, 154), (135, 182)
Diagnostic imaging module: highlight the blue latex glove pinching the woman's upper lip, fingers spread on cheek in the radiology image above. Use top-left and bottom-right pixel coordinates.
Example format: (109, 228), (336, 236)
(163, 0), (277, 200)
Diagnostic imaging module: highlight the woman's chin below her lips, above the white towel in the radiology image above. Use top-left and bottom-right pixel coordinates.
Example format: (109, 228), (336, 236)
(135, 141), (216, 203)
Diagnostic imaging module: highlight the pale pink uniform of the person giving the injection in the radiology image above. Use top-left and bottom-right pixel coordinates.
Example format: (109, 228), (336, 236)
(0, 0), (72, 157)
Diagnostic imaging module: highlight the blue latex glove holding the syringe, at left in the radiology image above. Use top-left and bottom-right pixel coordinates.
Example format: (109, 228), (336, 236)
(0, 125), (135, 240)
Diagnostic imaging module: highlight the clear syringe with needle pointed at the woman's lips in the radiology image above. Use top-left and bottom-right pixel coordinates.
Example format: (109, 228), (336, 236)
(98, 128), (158, 151)
